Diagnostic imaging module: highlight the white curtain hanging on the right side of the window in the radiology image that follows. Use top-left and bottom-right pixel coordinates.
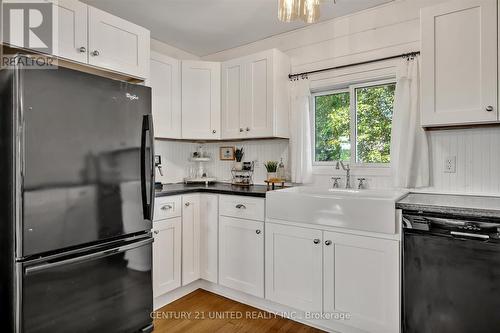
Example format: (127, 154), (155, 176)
(391, 56), (429, 188)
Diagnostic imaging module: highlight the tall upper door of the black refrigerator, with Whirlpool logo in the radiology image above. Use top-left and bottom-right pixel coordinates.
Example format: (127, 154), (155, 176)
(18, 68), (154, 257)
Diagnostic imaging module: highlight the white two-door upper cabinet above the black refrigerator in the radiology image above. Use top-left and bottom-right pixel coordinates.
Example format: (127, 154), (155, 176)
(10, 0), (150, 79)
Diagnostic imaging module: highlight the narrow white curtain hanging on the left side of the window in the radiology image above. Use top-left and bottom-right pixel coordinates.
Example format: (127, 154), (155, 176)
(290, 79), (312, 183)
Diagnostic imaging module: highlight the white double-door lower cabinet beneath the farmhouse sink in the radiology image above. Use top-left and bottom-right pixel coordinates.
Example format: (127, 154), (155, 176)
(266, 223), (400, 333)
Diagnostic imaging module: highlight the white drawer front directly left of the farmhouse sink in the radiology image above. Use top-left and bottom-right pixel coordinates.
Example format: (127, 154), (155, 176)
(219, 195), (265, 221)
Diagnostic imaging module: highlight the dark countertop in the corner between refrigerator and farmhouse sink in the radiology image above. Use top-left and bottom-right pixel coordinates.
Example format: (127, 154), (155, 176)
(156, 183), (274, 198)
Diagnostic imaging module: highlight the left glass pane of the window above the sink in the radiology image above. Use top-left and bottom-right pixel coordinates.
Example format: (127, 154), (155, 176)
(315, 92), (351, 162)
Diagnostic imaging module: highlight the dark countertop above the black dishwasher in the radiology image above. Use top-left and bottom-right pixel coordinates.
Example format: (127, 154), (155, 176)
(396, 193), (500, 218)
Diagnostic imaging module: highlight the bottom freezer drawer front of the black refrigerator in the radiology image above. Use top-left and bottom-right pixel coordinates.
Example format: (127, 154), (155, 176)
(19, 238), (153, 333)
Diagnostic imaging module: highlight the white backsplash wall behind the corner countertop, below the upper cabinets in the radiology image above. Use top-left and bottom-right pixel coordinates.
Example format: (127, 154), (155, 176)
(155, 139), (288, 184)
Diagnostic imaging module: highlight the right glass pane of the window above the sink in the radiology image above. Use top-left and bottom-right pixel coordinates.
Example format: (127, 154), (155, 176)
(356, 84), (396, 163)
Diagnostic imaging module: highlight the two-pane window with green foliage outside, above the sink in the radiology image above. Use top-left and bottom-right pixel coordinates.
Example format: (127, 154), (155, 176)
(313, 81), (396, 165)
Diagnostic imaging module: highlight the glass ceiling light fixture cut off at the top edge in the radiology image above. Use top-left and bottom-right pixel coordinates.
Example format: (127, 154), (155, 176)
(278, 0), (336, 23)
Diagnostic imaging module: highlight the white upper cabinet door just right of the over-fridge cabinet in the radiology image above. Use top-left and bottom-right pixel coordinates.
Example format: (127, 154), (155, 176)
(147, 52), (181, 139)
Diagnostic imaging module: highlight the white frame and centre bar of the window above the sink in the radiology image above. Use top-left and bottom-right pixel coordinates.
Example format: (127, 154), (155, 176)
(310, 77), (396, 170)
